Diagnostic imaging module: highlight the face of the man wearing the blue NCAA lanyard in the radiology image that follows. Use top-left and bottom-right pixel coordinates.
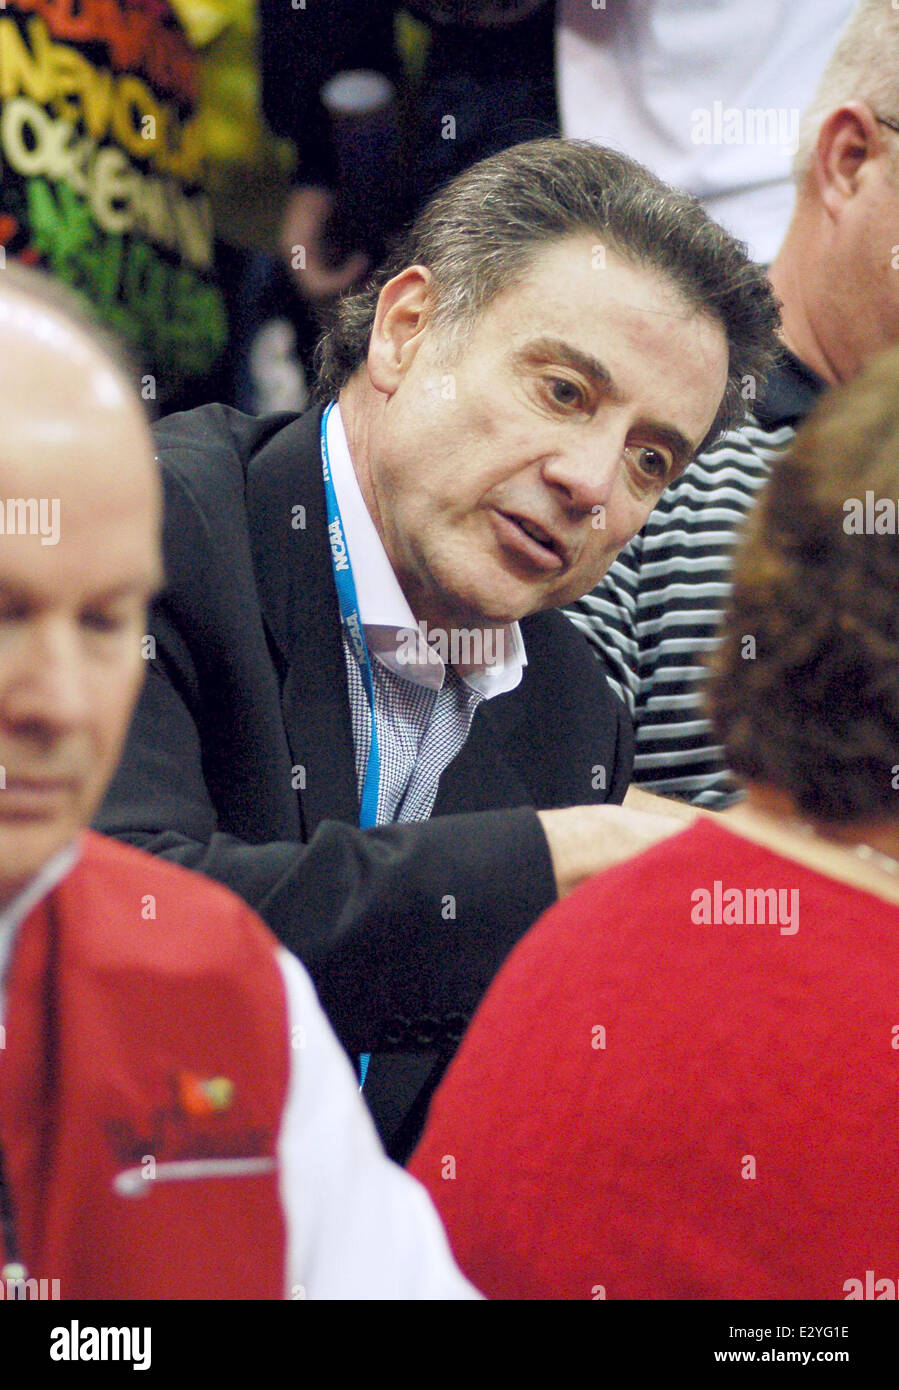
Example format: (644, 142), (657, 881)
(365, 236), (728, 626)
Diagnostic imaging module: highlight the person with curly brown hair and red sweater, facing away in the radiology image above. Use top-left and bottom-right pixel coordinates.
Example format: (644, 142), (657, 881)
(411, 341), (899, 1300)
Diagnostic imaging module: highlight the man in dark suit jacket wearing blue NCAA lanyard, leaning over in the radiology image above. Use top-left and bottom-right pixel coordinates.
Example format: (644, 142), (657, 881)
(99, 140), (775, 1156)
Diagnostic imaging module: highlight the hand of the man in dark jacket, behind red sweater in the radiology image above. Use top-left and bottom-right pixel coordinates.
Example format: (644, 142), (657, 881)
(538, 798), (692, 898)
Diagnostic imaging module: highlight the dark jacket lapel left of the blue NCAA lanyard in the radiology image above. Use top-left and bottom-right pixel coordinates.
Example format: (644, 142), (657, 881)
(247, 410), (358, 840)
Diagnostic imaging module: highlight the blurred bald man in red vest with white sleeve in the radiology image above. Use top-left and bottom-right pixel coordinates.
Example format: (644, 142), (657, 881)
(0, 268), (475, 1298)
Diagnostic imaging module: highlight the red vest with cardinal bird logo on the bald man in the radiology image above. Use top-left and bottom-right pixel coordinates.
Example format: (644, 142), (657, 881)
(0, 833), (289, 1298)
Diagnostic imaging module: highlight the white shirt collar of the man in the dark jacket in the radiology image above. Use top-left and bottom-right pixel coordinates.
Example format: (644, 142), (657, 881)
(328, 404), (528, 699)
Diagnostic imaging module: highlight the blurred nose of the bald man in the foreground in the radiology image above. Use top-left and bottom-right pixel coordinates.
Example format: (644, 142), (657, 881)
(0, 617), (90, 733)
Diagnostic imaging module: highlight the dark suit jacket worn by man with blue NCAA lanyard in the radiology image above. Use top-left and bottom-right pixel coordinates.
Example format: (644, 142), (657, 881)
(96, 406), (632, 1154)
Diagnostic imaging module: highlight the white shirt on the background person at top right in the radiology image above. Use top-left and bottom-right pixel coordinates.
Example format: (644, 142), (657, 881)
(556, 0), (853, 264)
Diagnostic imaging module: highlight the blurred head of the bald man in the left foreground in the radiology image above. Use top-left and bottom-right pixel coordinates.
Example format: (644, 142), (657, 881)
(0, 270), (161, 904)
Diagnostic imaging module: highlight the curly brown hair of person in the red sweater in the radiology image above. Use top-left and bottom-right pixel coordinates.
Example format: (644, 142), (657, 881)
(707, 349), (899, 823)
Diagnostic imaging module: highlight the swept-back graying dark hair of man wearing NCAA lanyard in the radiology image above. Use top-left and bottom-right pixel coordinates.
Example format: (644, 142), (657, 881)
(315, 139), (778, 445)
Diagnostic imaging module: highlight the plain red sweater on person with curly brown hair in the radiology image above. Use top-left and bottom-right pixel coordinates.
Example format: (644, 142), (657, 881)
(410, 820), (899, 1298)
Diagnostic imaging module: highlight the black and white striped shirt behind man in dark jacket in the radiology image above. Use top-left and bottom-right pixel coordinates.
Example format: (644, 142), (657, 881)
(567, 353), (824, 809)
